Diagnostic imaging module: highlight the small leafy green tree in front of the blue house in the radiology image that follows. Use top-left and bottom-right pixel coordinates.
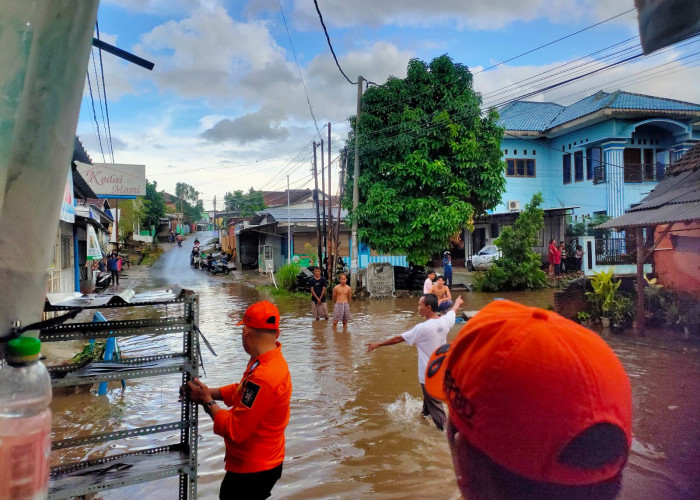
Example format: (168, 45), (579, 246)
(473, 193), (547, 292)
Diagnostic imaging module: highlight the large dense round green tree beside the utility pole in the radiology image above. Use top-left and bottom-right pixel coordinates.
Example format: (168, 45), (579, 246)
(345, 55), (505, 264)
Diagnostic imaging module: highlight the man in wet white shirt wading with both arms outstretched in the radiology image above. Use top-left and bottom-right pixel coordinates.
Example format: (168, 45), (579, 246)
(366, 293), (463, 431)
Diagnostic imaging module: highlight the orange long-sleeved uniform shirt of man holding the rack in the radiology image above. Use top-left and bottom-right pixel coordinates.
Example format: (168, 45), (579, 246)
(214, 342), (292, 473)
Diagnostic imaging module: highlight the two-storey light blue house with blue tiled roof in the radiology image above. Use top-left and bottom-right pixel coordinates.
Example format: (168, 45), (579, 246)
(464, 90), (700, 262)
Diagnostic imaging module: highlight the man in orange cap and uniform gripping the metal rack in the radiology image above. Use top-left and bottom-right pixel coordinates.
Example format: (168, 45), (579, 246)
(185, 301), (292, 499)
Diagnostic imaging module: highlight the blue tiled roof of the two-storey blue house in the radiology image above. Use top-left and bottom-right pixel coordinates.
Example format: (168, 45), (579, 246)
(499, 90), (700, 132)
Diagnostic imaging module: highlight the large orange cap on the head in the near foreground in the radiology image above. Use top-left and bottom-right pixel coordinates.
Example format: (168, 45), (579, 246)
(425, 300), (632, 485)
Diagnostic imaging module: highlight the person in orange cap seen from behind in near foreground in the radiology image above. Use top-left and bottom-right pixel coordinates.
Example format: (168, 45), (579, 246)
(425, 300), (632, 500)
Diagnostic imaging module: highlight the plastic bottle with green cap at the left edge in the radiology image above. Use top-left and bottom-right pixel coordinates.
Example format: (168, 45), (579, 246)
(0, 337), (51, 500)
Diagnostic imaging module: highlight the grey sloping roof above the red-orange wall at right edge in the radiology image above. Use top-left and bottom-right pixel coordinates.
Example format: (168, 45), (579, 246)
(596, 169), (700, 229)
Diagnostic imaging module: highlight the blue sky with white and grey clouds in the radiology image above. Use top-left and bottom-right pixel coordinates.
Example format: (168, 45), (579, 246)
(77, 0), (700, 209)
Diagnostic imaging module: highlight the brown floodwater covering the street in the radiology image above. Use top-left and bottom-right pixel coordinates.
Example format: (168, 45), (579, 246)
(52, 234), (700, 500)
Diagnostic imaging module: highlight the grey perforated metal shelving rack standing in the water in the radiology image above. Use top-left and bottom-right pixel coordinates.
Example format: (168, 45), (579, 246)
(40, 289), (200, 500)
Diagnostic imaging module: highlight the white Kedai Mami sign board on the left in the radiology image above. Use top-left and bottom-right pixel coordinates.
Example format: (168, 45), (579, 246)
(76, 162), (146, 198)
